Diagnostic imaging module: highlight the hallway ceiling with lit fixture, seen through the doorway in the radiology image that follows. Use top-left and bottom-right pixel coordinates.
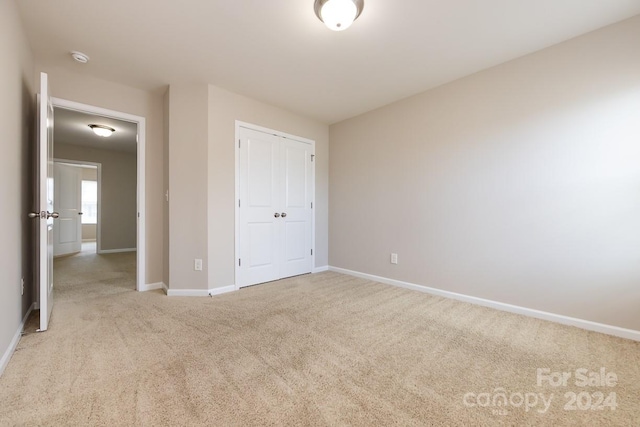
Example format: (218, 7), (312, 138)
(53, 108), (138, 155)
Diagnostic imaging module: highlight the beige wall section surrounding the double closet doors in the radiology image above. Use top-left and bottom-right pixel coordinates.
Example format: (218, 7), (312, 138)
(208, 86), (329, 288)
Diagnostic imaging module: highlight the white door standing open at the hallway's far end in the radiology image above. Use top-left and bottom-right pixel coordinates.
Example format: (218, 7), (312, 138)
(53, 162), (82, 256)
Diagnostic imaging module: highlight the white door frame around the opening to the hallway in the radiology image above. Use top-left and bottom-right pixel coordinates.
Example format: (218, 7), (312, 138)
(51, 97), (147, 291)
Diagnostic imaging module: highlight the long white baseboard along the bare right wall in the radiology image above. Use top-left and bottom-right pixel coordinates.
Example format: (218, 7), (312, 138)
(329, 266), (640, 341)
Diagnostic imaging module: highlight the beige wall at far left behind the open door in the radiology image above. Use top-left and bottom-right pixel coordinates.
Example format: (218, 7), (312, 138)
(0, 0), (35, 369)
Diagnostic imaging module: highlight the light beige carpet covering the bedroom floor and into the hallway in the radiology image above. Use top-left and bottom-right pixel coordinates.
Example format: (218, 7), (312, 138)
(0, 254), (640, 426)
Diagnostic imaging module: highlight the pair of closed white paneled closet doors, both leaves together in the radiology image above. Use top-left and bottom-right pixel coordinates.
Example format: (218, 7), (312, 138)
(236, 127), (314, 287)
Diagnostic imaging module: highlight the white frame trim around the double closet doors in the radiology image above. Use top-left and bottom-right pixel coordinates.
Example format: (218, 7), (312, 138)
(233, 120), (316, 291)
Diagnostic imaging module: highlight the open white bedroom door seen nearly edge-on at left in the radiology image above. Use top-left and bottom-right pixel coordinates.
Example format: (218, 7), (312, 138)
(35, 73), (58, 331)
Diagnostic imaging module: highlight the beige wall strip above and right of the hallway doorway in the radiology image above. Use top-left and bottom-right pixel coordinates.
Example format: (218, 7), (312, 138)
(36, 64), (166, 284)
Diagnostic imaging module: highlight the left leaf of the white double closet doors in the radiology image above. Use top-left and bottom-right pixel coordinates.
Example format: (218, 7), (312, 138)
(238, 129), (280, 286)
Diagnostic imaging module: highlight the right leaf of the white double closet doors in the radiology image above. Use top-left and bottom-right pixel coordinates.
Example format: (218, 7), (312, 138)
(280, 138), (313, 277)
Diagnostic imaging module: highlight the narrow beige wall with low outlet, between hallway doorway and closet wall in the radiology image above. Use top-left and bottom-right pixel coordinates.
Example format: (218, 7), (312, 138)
(168, 84), (210, 290)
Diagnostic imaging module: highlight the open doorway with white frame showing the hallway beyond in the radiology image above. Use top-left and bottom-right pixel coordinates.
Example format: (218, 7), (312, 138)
(52, 98), (146, 290)
